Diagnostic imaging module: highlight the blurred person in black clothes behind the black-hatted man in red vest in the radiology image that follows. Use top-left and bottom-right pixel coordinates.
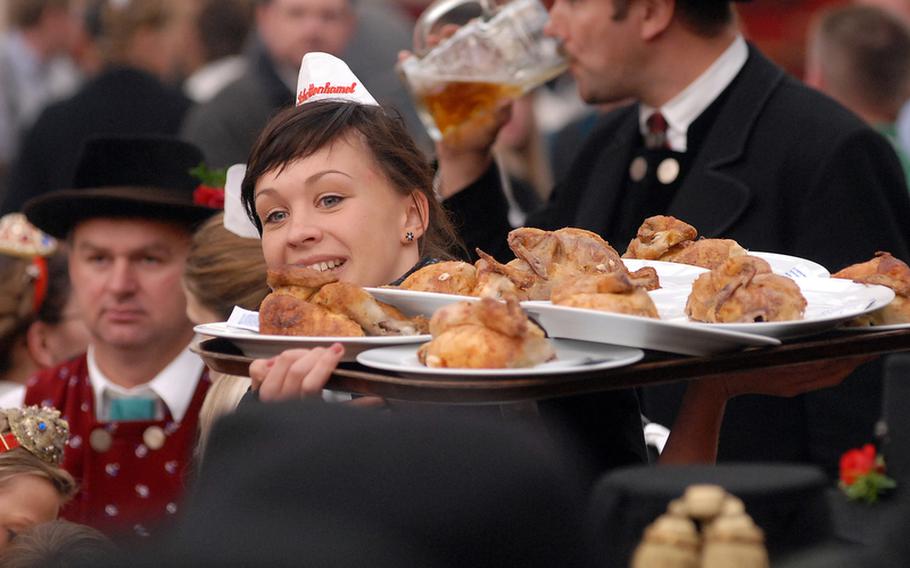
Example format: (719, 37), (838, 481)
(0, 0), (190, 212)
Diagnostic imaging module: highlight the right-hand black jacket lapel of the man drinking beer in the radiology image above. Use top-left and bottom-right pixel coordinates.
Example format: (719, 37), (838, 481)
(670, 46), (784, 237)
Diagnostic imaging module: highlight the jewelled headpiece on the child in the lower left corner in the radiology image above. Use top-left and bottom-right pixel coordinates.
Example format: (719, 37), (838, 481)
(0, 406), (69, 466)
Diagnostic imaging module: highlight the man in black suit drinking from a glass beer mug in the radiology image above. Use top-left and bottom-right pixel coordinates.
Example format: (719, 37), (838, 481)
(439, 0), (910, 469)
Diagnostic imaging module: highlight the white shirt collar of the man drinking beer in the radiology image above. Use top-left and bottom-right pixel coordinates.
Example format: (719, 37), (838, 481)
(638, 35), (749, 152)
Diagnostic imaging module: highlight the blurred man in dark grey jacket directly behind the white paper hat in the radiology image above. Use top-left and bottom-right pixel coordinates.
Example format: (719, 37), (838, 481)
(182, 0), (429, 167)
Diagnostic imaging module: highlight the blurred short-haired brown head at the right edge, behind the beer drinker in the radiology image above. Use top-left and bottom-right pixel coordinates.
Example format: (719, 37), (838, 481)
(806, 6), (910, 185)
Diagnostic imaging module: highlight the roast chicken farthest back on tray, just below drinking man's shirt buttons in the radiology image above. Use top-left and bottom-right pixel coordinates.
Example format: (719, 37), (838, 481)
(623, 215), (747, 270)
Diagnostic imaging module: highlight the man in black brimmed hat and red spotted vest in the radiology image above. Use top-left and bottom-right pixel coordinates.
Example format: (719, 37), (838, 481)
(25, 138), (213, 535)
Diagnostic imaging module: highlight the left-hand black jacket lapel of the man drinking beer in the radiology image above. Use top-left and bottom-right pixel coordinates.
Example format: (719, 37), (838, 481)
(574, 104), (640, 235)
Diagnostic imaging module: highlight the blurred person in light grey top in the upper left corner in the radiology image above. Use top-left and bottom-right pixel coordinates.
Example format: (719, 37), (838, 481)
(0, 0), (80, 202)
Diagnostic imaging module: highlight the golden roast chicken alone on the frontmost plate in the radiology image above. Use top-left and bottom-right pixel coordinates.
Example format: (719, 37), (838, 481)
(417, 298), (555, 369)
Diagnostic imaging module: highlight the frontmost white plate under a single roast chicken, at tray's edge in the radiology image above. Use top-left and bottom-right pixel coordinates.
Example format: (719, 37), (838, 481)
(357, 339), (645, 378)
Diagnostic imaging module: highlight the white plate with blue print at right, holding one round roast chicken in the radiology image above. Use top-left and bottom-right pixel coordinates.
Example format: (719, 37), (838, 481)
(649, 277), (894, 338)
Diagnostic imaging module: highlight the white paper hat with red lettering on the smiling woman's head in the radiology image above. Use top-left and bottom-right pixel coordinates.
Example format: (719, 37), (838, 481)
(297, 51), (379, 106)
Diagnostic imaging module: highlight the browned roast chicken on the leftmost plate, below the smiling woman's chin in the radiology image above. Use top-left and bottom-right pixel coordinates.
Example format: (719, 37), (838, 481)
(259, 267), (426, 337)
